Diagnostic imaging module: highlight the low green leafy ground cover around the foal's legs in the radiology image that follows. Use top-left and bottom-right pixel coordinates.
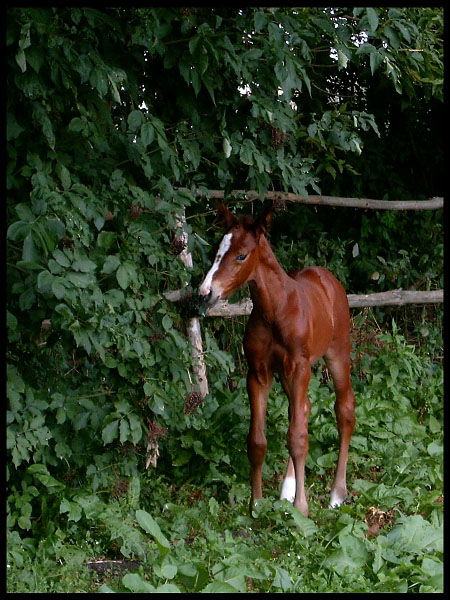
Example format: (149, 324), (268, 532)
(7, 325), (443, 593)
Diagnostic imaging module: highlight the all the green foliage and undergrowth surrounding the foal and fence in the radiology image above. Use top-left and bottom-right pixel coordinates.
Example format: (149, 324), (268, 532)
(6, 7), (444, 591)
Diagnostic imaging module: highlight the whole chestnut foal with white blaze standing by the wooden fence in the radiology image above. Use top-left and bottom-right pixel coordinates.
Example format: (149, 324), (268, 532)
(199, 202), (355, 516)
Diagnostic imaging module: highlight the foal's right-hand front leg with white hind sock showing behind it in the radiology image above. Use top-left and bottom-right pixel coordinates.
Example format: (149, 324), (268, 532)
(281, 359), (311, 517)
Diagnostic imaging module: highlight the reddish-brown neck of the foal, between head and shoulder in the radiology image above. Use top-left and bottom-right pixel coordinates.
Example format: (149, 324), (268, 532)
(249, 238), (292, 323)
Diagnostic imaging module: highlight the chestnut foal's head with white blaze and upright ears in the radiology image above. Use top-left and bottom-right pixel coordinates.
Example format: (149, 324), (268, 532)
(198, 202), (272, 306)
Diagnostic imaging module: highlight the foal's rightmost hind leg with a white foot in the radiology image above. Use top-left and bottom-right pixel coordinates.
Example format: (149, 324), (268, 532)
(325, 350), (355, 507)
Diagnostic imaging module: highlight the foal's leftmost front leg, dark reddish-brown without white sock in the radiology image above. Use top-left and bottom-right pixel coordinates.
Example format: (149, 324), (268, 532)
(247, 369), (273, 515)
